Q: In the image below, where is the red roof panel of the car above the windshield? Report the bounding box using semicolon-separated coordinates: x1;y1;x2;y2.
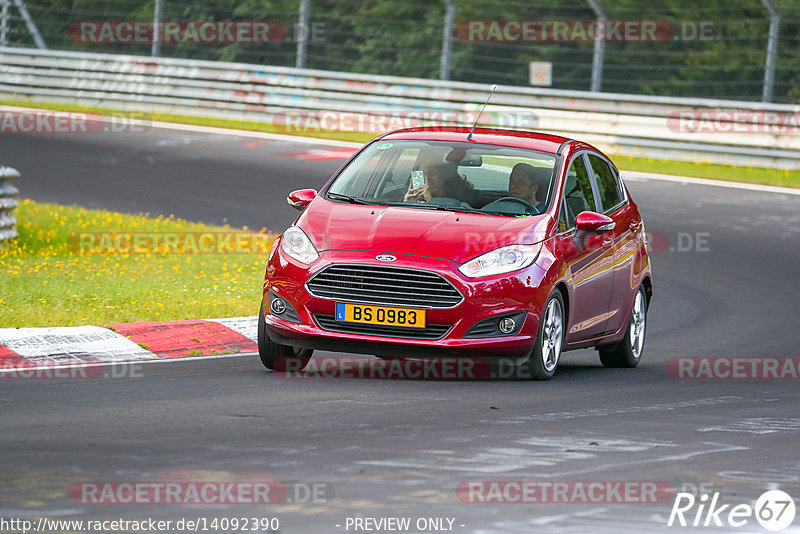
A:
381;126;573;154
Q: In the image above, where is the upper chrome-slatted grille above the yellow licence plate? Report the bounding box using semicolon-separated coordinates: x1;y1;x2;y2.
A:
306;265;464;308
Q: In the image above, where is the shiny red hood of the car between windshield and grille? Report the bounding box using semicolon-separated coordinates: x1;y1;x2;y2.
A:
296;197;551;263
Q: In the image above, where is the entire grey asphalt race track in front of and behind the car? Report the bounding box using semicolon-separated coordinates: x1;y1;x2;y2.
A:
0;126;800;533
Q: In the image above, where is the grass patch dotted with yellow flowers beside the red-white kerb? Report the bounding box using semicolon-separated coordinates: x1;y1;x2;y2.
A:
0;200;274;327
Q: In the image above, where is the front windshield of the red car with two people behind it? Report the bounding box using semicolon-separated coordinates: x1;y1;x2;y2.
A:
327;140;556;220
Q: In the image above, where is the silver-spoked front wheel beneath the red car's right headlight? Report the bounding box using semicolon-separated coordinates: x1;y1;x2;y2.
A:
521;290;566;380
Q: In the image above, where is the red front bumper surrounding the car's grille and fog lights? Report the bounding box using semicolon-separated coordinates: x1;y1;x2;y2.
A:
264;246;547;358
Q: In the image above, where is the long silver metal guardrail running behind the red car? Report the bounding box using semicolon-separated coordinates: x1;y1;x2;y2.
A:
0;48;800;169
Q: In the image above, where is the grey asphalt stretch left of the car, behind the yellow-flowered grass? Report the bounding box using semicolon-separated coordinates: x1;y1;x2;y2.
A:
0;128;343;231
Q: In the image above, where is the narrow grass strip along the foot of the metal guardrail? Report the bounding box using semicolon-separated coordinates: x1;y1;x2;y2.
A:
0;100;800;188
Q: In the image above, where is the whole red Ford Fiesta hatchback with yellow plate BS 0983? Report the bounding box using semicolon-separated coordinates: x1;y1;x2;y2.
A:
258;127;653;380
